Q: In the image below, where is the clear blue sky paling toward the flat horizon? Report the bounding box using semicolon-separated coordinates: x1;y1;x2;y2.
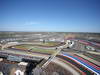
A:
0;0;100;32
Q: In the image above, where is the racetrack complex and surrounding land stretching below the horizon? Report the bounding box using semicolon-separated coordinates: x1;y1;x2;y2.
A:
0;32;100;75
